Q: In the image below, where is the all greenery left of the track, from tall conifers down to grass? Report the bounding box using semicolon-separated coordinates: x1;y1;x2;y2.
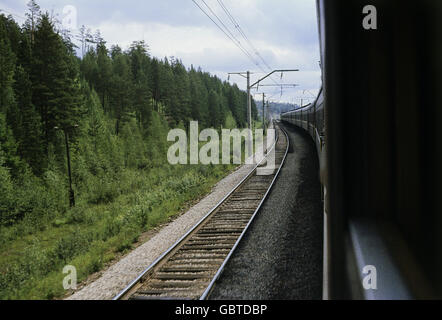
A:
0;1;257;299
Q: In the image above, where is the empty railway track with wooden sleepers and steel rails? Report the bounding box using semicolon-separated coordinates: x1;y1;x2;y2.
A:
114;127;289;300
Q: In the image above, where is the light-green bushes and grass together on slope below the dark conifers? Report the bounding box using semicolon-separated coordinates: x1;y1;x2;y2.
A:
0;109;266;299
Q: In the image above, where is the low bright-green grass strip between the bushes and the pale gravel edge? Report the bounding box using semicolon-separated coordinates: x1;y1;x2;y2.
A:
0;165;234;299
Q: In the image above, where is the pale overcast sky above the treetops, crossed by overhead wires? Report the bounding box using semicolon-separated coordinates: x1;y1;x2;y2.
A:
0;0;321;103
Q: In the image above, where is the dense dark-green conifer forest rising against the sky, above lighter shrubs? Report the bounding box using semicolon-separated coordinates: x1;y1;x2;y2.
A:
0;0;257;224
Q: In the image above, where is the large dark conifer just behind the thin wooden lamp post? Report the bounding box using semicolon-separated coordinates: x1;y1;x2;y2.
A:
31;14;80;155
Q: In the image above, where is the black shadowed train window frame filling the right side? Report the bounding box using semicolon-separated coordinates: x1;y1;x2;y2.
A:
318;0;442;298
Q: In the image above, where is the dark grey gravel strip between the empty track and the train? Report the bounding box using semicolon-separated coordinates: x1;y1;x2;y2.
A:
210;123;323;300
